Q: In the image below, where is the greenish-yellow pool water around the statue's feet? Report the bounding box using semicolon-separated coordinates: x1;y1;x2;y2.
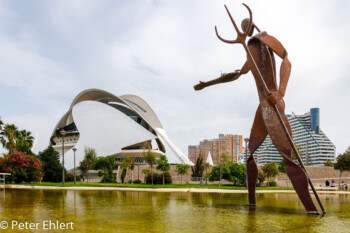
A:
0;189;350;232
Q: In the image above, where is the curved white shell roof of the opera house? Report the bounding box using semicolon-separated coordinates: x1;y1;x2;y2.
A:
52;89;193;165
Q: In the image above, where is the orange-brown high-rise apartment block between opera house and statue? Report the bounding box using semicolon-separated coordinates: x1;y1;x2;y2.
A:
188;134;243;165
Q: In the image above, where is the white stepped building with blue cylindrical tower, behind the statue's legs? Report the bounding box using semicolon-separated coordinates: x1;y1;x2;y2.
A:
254;108;336;166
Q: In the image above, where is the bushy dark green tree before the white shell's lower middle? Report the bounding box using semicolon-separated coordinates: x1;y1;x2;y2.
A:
92;156;115;183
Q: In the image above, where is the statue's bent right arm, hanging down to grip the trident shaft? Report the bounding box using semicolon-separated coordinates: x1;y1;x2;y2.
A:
255;32;292;97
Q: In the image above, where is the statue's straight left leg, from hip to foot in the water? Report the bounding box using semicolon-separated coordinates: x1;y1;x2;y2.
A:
247;106;267;205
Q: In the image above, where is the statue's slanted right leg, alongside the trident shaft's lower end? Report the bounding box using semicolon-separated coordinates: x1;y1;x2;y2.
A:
261;99;318;214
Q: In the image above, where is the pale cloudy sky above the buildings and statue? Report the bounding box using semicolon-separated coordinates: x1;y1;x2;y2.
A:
0;0;350;167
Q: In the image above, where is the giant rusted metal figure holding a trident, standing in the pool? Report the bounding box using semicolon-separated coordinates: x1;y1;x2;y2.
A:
194;4;326;214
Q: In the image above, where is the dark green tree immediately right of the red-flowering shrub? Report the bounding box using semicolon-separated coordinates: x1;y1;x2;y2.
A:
38;145;62;182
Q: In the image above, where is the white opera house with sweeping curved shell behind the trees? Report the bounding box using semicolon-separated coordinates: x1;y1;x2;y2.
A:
51;89;193;167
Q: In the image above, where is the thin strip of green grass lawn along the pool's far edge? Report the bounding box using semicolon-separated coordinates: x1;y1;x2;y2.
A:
17;181;293;190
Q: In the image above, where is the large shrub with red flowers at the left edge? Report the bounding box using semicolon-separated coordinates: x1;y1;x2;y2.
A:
0;151;43;184
